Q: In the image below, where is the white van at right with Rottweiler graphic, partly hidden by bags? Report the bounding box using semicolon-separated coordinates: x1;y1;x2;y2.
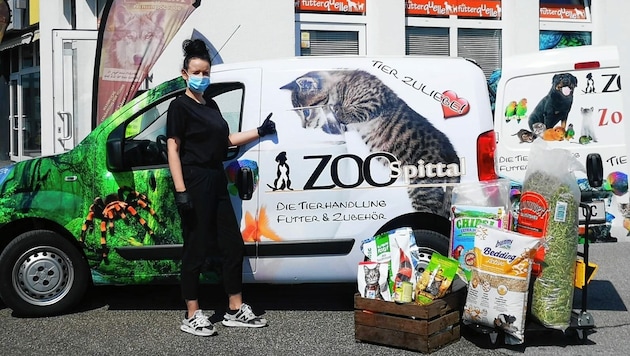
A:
494;46;630;241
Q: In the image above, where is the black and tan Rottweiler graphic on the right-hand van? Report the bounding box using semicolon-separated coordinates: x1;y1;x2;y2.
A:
529;73;577;130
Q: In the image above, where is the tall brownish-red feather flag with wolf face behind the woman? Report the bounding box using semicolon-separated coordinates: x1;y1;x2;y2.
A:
94;0;200;124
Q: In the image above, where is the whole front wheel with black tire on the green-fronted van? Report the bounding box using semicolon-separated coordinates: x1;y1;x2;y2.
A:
0;230;90;316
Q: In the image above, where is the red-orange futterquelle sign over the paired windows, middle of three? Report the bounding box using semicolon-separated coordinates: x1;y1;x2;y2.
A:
407;0;501;18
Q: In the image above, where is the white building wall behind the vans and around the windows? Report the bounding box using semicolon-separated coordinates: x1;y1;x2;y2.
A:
0;0;630;160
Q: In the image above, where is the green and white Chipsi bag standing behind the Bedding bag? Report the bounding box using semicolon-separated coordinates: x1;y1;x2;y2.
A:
448;179;509;282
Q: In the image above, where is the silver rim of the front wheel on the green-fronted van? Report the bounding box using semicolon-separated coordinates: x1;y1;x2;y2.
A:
13;246;74;306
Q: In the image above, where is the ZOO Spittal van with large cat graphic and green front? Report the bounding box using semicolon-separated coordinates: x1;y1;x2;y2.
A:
0;57;496;315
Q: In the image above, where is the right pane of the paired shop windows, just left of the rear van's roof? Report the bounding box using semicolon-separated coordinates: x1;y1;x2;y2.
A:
457;28;501;78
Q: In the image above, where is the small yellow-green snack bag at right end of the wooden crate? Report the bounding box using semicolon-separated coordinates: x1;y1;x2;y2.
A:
416;252;459;304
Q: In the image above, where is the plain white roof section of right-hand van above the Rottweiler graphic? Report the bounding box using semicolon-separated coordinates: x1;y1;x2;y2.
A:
501;45;619;77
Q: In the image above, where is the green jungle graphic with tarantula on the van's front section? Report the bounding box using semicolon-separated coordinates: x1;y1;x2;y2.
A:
0;78;227;283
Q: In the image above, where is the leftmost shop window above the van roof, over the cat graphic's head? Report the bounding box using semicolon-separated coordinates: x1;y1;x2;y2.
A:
300;30;359;56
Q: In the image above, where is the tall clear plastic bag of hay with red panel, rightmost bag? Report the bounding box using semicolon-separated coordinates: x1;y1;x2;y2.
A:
517;140;585;330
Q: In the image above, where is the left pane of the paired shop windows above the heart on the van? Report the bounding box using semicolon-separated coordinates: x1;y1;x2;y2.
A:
405;27;450;56
